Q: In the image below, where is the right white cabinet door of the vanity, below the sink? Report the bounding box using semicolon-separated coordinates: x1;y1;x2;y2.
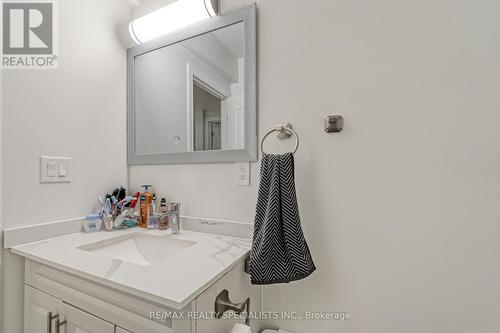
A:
60;303;115;333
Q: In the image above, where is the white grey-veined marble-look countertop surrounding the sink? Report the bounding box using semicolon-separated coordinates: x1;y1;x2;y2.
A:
12;228;251;310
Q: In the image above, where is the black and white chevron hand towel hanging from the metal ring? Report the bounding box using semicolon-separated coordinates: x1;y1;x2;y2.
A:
249;153;316;284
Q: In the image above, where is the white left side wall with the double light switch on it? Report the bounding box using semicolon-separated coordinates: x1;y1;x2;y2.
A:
1;0;130;333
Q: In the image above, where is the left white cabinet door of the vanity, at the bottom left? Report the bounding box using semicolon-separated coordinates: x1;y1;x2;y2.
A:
24;285;62;333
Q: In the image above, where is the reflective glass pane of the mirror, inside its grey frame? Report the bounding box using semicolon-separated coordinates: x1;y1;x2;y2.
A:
134;23;245;154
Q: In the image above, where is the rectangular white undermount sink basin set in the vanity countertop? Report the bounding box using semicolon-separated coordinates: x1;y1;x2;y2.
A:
79;232;196;266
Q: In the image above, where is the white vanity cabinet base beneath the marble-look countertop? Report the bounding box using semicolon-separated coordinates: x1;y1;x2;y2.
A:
24;259;261;333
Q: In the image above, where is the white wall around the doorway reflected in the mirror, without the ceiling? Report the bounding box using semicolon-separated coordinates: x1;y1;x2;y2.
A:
134;44;230;154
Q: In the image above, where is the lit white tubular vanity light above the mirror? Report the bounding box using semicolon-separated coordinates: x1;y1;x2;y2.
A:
129;0;219;44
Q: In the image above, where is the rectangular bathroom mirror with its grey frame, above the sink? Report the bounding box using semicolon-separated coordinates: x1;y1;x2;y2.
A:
127;5;257;165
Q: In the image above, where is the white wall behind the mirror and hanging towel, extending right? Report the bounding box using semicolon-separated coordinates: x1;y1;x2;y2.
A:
129;0;500;333
